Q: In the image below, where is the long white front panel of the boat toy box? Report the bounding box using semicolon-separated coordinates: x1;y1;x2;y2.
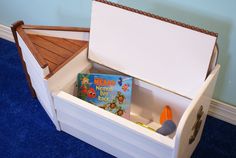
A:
54;92;173;158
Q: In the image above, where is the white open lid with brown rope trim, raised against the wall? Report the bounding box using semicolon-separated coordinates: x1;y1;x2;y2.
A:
88;0;217;98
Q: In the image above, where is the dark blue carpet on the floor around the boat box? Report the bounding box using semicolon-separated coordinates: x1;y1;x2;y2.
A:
0;38;236;158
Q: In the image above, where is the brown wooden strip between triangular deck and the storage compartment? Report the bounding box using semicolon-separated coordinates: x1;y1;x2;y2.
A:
45;43;88;80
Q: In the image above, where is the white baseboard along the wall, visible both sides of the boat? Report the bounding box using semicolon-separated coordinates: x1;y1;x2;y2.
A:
0;24;236;125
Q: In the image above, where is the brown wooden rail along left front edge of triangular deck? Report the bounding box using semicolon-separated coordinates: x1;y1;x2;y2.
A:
16;26;48;68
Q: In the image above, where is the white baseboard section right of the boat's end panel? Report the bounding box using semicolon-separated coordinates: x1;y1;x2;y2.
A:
208;99;236;125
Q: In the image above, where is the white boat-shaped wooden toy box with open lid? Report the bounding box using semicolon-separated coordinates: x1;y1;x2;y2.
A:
12;0;220;158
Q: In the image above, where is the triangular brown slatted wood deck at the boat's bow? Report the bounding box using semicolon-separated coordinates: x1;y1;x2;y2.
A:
28;34;88;74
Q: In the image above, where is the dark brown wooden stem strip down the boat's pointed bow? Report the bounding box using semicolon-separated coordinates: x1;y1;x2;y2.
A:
11;21;36;98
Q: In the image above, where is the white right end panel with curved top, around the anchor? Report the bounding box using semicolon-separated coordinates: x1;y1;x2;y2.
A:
174;65;220;158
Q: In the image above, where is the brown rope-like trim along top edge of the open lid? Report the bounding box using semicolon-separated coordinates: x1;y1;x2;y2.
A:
95;0;218;37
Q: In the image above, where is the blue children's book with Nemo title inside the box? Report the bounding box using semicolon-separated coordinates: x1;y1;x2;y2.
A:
77;73;132;119
